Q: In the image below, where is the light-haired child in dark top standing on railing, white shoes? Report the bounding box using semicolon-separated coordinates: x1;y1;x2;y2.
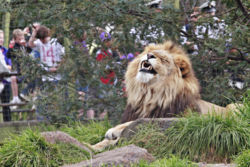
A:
7;29;31;104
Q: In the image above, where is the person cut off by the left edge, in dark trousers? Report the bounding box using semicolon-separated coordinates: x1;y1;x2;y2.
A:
0;30;11;121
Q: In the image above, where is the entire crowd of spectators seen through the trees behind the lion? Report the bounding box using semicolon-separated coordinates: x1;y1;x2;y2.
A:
0;0;244;121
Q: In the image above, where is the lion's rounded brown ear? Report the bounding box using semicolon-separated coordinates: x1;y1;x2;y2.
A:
174;57;191;78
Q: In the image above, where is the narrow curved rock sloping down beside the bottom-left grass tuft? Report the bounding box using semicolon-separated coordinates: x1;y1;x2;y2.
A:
41;131;93;156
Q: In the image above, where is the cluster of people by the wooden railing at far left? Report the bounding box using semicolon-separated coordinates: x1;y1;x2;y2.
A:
0;23;64;121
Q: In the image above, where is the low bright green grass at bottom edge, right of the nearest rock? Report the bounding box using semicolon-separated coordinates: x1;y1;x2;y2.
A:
132;156;198;167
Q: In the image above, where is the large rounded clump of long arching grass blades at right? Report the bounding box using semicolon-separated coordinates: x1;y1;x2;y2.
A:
166;115;250;162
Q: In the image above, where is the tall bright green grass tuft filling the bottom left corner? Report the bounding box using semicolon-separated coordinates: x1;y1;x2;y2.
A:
0;130;63;167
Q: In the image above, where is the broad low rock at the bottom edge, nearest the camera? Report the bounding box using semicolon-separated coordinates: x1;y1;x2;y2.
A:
63;145;154;167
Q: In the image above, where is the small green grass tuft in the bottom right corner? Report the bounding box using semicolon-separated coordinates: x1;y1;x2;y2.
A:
235;149;250;167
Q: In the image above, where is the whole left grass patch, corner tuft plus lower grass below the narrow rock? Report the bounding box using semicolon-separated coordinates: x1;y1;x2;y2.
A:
0;129;90;167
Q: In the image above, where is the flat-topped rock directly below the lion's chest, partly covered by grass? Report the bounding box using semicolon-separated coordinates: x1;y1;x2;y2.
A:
121;118;178;139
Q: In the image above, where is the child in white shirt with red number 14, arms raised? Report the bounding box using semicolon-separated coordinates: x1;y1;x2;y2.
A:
29;26;65;81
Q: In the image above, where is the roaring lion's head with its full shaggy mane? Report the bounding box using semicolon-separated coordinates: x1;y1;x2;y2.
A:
122;41;200;122
